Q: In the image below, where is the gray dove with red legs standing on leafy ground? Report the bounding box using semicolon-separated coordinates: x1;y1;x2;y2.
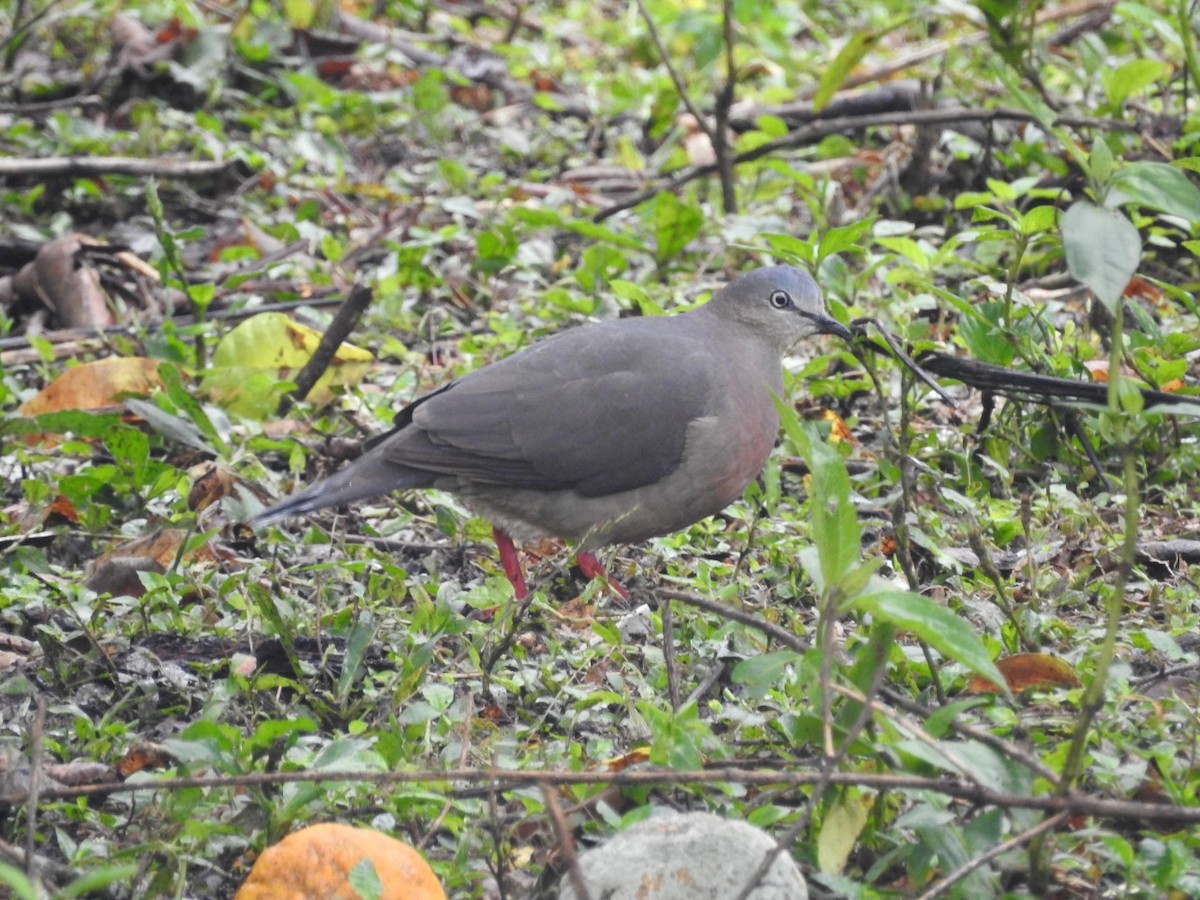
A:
256;271;850;599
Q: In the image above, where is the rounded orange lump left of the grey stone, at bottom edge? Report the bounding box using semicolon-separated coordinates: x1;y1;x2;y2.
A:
234;822;445;900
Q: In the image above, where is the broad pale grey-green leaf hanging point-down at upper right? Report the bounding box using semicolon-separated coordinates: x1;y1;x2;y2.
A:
1062;200;1141;312
